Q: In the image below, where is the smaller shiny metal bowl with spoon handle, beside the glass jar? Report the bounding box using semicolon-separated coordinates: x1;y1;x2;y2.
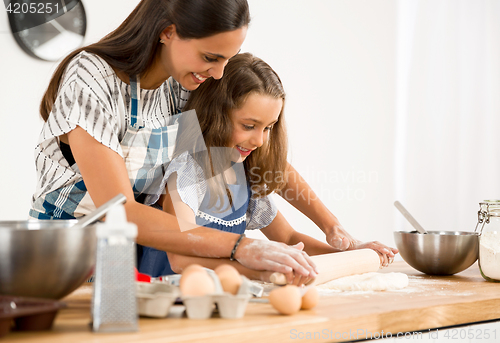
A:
394;231;479;275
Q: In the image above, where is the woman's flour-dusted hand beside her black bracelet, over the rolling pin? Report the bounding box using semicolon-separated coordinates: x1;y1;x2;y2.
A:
234;238;318;283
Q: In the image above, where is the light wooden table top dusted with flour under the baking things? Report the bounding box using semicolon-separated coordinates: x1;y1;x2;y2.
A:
2;262;500;343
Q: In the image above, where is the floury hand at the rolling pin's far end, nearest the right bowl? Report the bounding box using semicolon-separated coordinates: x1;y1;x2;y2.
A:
326;224;399;267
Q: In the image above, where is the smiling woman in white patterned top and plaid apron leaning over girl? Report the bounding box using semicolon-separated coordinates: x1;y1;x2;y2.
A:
30;0;391;284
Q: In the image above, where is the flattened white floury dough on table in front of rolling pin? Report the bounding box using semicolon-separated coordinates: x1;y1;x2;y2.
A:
317;272;408;291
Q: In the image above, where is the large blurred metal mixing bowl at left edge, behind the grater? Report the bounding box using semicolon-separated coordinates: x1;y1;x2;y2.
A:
0;220;97;299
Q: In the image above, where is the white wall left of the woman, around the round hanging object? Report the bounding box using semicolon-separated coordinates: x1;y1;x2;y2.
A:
0;0;138;220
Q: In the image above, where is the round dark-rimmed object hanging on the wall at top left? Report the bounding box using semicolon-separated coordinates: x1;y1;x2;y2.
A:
4;0;87;61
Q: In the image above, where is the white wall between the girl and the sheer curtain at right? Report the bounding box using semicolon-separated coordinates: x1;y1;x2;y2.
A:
243;0;396;245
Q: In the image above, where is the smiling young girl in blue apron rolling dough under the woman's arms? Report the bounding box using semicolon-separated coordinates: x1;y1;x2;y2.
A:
140;53;398;283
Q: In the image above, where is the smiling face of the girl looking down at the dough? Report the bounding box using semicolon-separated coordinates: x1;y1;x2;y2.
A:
229;93;283;162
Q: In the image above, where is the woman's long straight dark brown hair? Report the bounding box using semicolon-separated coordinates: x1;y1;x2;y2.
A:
40;0;250;121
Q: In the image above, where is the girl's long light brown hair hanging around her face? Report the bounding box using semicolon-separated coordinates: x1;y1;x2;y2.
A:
182;53;288;205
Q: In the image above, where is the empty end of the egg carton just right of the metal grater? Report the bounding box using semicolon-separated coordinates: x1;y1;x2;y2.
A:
135;282;181;318
